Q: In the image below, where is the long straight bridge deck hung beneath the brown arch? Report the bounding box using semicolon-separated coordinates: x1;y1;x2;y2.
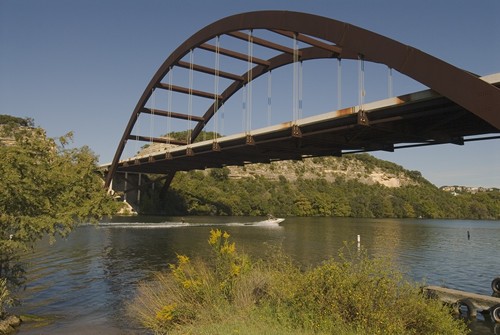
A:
102;73;500;174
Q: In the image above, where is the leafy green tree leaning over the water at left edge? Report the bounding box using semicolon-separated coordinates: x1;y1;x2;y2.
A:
0;124;118;296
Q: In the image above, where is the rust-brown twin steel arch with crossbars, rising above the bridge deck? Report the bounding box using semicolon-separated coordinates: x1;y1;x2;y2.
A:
106;11;500;186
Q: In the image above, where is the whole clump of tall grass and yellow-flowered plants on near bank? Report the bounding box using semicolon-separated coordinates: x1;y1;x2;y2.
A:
128;230;468;335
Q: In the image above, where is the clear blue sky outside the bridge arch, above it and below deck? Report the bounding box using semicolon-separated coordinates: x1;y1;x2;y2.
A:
0;0;500;187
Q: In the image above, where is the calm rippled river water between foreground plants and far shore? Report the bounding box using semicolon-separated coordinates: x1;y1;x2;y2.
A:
13;217;500;335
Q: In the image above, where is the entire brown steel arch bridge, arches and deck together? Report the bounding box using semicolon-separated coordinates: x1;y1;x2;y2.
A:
105;11;500;192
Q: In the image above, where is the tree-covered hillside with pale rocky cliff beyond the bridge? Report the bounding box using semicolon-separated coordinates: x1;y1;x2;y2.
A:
141;154;500;219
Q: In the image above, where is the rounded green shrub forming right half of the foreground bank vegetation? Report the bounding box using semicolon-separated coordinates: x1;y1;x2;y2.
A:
270;247;466;334
